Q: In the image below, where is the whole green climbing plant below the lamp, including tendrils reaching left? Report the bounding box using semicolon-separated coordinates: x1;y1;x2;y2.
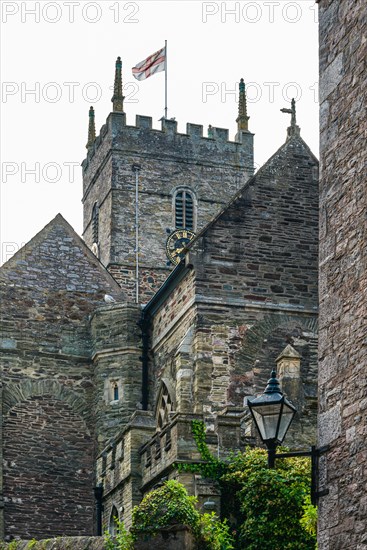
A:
181;421;317;550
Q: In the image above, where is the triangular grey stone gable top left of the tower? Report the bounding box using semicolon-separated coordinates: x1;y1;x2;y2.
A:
0;214;123;300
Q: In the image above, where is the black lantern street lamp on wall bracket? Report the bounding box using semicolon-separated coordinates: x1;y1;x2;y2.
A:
247;370;329;505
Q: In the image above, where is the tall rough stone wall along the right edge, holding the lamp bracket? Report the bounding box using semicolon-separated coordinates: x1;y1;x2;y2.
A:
319;0;367;550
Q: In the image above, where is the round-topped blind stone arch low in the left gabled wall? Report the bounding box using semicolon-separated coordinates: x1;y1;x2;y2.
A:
4;396;94;539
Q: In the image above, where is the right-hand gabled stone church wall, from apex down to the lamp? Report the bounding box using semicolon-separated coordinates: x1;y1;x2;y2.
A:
188;137;318;446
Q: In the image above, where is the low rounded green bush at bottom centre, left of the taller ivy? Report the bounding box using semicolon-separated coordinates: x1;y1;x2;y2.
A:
133;480;234;550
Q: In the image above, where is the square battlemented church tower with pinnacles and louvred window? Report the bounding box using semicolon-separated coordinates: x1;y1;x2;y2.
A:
82;57;254;303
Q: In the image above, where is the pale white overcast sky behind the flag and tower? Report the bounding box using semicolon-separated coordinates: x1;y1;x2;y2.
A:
0;0;318;268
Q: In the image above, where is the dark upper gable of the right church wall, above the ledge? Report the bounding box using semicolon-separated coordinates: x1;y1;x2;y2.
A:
191;137;318;310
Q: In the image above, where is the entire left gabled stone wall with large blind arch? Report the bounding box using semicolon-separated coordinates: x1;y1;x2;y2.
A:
0;216;121;536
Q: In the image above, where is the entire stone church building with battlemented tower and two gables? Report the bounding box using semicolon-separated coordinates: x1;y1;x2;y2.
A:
0;59;318;540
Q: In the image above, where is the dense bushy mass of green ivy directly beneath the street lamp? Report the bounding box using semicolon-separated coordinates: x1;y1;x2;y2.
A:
222;448;316;550
